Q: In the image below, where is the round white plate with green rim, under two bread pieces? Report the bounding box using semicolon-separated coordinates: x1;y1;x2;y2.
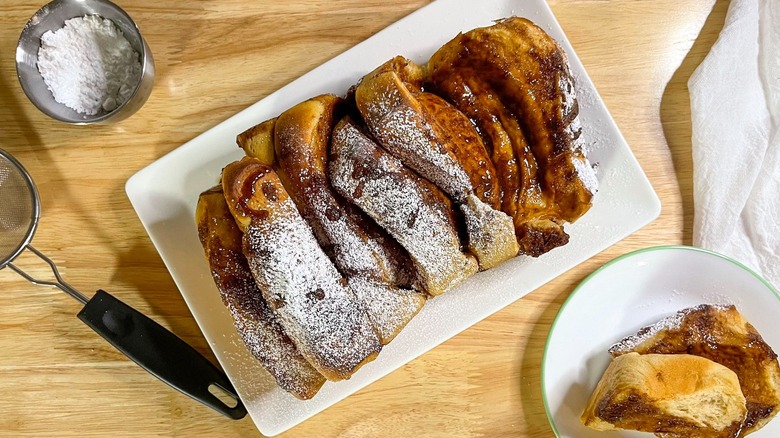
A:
542;246;780;438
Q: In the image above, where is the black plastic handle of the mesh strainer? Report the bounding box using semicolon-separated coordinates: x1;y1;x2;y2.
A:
78;290;246;420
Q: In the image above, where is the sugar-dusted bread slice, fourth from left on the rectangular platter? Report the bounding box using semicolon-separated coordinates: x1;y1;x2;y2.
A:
329;119;477;294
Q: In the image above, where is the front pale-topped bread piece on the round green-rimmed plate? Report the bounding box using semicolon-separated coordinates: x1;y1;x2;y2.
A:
581;353;747;437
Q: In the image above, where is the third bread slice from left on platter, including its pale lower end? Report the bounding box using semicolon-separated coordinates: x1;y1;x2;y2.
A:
274;94;425;345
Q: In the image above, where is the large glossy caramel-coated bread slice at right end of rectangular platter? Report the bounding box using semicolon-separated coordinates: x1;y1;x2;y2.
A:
428;17;597;256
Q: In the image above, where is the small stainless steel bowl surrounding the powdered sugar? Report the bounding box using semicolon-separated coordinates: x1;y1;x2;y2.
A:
16;0;154;125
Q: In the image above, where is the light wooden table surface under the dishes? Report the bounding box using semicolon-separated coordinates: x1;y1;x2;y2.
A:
0;0;728;437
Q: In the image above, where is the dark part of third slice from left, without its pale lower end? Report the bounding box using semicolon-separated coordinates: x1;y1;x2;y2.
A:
274;94;414;286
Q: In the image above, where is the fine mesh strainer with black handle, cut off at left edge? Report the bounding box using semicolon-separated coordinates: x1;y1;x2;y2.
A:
0;149;246;419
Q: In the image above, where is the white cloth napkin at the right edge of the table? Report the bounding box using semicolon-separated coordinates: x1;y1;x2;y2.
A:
688;0;780;287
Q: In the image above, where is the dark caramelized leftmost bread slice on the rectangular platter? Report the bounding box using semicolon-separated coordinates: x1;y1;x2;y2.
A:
196;187;325;400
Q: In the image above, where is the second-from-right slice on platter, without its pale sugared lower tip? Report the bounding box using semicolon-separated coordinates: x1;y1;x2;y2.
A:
355;56;499;208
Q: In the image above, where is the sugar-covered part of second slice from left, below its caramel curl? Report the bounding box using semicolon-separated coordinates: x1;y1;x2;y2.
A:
244;175;381;380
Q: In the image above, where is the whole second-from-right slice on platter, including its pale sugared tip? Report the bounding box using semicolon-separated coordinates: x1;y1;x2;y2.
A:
355;57;518;269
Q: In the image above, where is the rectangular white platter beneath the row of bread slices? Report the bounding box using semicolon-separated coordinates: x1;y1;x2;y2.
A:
126;0;660;435
